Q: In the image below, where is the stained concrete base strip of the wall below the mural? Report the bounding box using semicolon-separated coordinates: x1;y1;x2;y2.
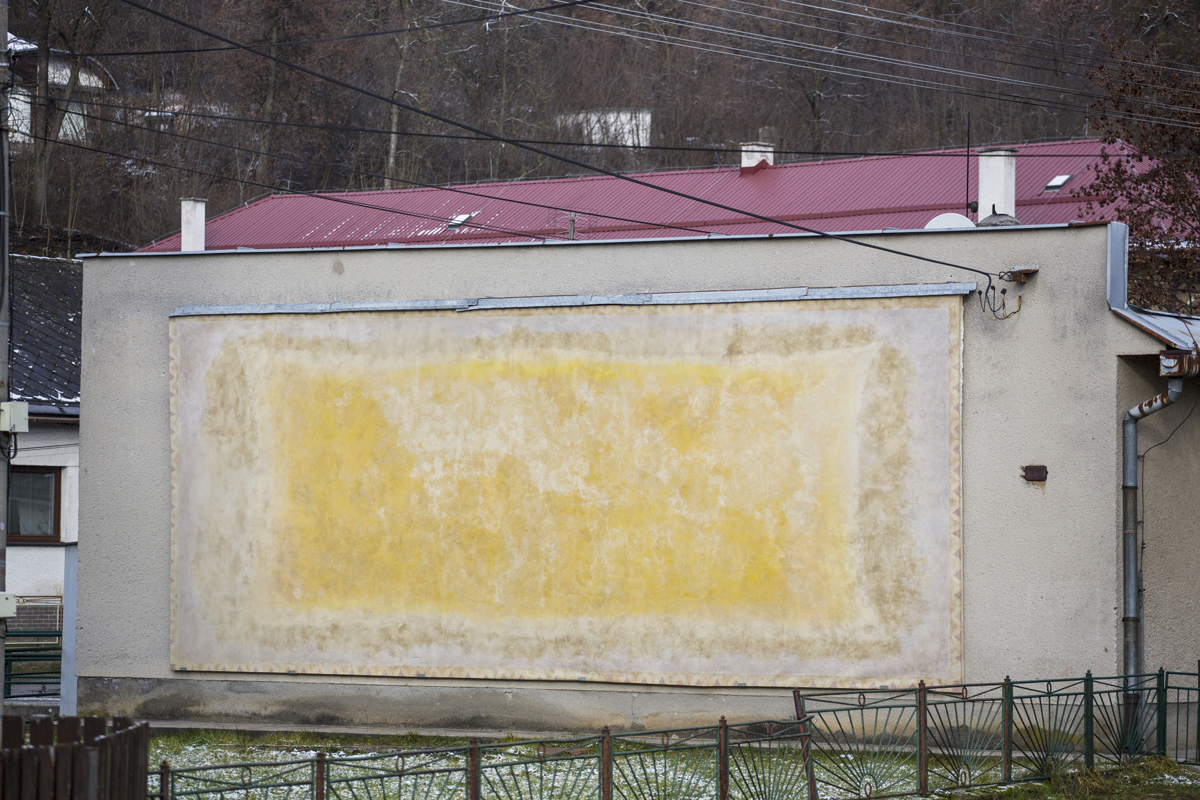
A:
79;678;796;732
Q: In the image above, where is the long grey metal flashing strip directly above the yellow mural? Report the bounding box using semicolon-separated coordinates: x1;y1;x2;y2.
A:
170;283;976;317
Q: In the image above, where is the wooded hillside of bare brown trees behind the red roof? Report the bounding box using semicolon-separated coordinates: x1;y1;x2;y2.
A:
11;0;1200;254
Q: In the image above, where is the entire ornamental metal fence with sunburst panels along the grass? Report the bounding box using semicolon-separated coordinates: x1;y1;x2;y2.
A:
149;668;1200;800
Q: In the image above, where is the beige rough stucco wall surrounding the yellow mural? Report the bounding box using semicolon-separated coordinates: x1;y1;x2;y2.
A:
77;221;1195;728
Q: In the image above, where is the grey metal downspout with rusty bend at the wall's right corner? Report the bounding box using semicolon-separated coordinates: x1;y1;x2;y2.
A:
1121;378;1183;688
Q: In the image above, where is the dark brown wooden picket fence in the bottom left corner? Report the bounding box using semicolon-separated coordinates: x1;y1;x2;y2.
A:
0;715;150;800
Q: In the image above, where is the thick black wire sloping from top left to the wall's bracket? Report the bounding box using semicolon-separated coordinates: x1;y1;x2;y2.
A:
121;0;1022;316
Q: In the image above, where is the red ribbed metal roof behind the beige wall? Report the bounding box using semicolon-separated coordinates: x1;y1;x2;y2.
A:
142;139;1100;252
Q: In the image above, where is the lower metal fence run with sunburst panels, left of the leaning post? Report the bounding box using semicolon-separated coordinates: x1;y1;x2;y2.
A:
149;718;809;800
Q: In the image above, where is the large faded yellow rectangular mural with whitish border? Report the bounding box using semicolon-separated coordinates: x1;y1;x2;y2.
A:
170;296;961;686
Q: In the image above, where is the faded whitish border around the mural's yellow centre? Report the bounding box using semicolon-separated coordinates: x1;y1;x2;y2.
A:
170;296;962;687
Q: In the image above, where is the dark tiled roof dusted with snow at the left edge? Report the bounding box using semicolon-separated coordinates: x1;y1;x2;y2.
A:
10;255;83;416
